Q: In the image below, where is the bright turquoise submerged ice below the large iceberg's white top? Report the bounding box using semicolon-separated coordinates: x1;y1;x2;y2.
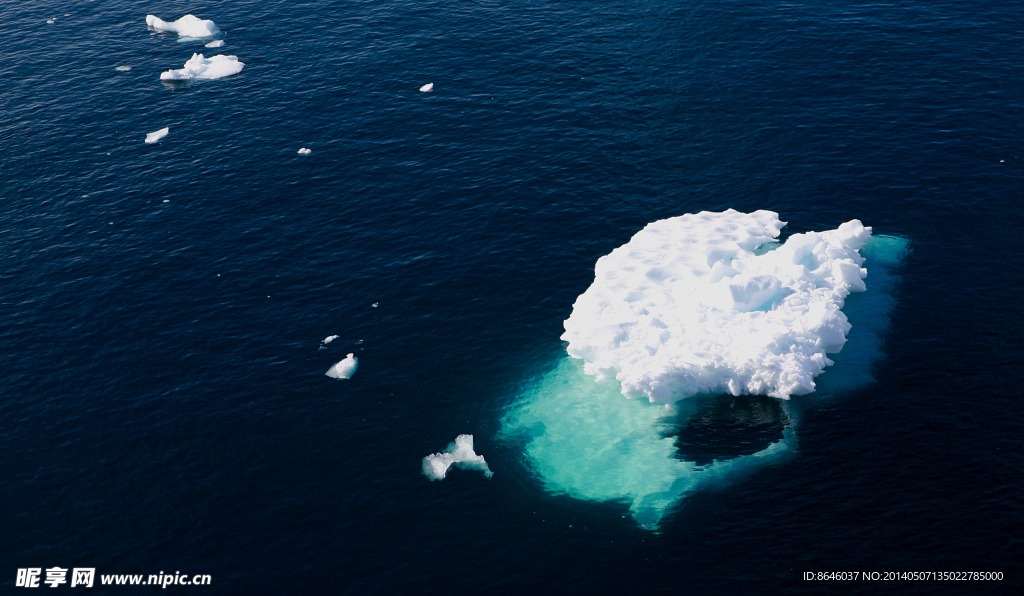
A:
502;358;797;528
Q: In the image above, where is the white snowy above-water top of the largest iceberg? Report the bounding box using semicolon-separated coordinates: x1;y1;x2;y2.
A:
562;209;871;403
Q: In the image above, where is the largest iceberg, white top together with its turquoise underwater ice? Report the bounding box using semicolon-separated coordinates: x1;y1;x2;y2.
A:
501;210;906;528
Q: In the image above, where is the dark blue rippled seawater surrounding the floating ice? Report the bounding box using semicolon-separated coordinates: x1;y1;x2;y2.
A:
0;0;1024;594
